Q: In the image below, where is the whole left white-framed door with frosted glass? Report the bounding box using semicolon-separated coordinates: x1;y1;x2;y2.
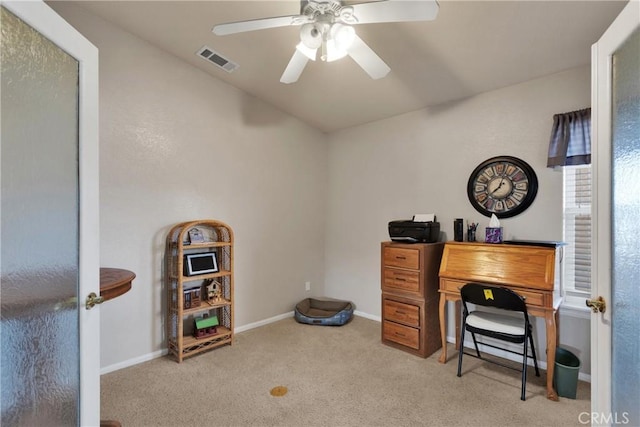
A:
0;0;100;426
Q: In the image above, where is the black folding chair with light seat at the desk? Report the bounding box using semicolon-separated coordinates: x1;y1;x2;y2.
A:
458;283;540;400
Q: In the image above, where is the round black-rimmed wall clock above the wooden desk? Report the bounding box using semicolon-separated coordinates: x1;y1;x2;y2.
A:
467;156;538;218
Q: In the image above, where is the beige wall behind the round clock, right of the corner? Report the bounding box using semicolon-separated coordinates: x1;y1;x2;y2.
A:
325;66;591;372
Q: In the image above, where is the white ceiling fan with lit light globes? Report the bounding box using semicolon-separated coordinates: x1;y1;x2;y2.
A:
213;0;439;83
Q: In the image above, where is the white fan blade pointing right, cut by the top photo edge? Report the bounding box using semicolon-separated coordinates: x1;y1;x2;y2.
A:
352;0;439;24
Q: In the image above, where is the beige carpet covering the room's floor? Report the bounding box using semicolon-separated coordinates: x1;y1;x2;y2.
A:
101;317;590;427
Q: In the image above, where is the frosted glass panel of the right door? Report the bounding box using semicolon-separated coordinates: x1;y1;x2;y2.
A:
611;28;640;426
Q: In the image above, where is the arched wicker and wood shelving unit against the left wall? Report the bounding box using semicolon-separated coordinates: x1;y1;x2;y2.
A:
165;220;233;362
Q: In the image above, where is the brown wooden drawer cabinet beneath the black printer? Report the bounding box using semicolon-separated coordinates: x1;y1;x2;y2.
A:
381;242;444;357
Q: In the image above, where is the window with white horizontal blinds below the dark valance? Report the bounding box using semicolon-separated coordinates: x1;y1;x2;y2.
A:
563;165;591;294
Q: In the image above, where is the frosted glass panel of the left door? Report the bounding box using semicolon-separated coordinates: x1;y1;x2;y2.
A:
0;7;80;426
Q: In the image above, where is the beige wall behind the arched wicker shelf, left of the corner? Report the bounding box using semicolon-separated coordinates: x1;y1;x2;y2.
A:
53;4;328;367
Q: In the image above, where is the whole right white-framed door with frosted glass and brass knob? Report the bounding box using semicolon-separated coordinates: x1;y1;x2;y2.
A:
592;0;640;426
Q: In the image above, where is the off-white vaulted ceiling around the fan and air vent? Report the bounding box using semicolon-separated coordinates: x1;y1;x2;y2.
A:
58;0;626;132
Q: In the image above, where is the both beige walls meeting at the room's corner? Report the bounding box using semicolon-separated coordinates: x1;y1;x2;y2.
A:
53;3;590;369
